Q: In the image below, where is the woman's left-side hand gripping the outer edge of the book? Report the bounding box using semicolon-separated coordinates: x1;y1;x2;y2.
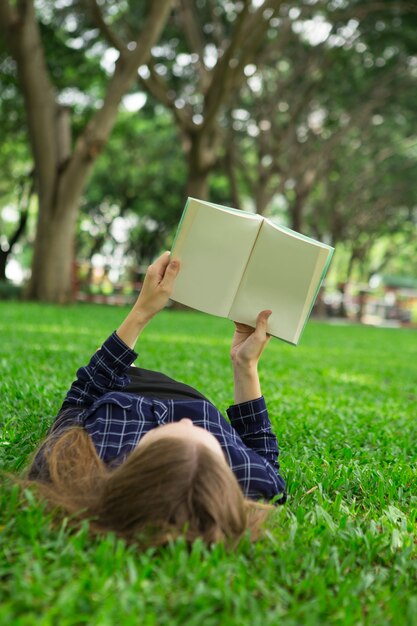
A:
133;252;180;321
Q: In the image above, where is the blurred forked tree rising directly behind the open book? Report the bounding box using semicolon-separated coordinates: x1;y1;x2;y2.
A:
136;0;283;198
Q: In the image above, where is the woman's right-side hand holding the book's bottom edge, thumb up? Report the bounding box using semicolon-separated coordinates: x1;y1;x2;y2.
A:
230;310;272;367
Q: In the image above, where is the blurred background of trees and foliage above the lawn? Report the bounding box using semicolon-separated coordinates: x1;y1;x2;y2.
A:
0;0;417;326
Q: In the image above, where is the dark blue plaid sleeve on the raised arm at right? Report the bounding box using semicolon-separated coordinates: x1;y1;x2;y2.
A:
227;396;279;471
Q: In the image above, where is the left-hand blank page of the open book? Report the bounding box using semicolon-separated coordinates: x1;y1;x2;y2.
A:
171;198;262;317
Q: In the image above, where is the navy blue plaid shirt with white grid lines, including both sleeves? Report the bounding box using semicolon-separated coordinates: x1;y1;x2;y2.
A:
40;332;286;504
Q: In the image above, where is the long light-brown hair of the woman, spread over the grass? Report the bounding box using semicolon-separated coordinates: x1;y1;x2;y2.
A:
18;427;274;545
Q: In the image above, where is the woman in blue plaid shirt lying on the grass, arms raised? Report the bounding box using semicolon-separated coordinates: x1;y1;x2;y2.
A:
24;253;286;545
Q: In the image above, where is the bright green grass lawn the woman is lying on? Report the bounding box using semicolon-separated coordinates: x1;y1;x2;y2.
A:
0;303;417;626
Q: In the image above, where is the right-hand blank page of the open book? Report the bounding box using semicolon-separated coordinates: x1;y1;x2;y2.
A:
229;220;330;344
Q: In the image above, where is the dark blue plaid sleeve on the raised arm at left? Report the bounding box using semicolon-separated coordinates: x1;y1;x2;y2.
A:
61;331;137;410
